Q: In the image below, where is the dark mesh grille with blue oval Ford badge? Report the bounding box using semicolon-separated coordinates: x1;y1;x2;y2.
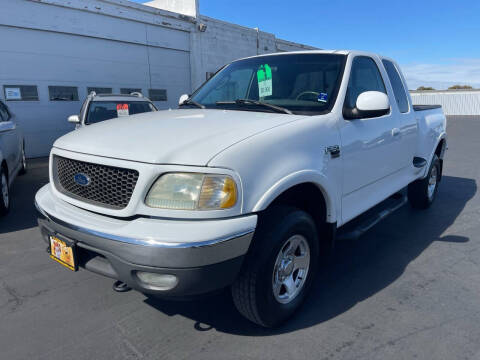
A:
53;155;138;210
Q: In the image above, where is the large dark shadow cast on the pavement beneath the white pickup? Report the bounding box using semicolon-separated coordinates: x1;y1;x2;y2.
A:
145;176;477;336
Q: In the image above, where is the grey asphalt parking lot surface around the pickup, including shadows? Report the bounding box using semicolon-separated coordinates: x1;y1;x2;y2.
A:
0;117;480;360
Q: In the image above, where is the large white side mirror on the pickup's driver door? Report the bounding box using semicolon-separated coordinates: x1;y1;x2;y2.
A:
343;91;390;120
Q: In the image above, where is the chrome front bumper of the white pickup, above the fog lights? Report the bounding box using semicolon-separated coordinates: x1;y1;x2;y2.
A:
35;185;257;267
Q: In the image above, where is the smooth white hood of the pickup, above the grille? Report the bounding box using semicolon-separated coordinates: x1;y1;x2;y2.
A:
54;109;303;166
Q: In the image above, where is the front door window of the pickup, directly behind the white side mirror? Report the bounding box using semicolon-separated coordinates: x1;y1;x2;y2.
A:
345;56;387;109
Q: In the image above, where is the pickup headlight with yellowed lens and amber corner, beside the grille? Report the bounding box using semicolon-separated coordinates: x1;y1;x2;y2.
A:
145;173;237;210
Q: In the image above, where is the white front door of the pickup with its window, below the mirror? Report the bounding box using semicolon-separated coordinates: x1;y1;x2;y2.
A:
340;56;401;223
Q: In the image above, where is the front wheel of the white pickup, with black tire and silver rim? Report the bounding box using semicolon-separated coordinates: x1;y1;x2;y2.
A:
231;207;319;327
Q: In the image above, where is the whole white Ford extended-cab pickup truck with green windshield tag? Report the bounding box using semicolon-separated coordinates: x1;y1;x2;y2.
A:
35;51;446;327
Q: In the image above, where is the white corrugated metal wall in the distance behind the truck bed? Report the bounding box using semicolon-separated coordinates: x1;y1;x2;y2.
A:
410;90;480;115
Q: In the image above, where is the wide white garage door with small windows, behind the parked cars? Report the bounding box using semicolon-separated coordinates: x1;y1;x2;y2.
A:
0;23;191;157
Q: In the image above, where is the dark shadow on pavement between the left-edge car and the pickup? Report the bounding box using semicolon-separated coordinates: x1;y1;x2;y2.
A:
0;159;48;234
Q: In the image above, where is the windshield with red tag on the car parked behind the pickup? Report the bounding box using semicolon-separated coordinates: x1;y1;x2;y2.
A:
85;101;156;125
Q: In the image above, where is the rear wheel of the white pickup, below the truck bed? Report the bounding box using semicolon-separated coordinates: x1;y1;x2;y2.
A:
408;155;442;209
